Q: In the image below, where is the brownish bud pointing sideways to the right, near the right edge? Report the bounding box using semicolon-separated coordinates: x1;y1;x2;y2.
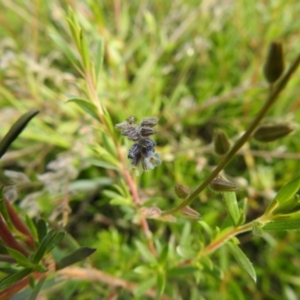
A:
253;124;295;142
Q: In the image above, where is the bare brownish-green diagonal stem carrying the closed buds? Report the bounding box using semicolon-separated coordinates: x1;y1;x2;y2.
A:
161;54;300;216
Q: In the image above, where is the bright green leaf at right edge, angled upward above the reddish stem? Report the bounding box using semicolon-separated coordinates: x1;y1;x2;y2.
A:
266;176;300;214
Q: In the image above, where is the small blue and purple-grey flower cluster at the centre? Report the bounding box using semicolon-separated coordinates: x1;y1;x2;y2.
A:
115;116;161;175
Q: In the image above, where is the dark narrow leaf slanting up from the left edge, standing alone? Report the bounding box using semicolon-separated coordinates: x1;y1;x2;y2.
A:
0;109;39;158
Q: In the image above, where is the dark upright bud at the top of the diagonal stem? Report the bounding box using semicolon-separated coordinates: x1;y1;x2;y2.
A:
263;42;284;84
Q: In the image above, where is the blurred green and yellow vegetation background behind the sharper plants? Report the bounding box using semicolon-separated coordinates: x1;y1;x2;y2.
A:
0;0;300;300
